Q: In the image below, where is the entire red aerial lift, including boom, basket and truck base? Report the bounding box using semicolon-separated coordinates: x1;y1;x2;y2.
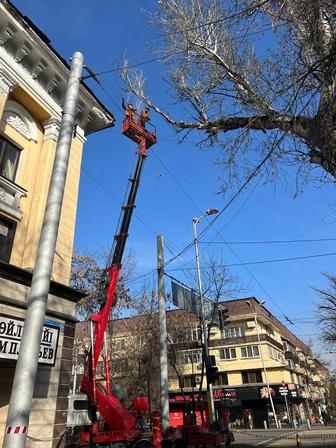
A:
67;117;234;448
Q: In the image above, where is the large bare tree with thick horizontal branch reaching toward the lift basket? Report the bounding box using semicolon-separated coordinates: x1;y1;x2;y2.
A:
123;0;336;188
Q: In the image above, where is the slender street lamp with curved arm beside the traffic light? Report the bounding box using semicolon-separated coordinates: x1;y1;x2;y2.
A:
193;208;219;424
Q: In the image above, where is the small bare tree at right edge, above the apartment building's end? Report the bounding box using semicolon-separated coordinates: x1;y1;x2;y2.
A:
314;274;336;347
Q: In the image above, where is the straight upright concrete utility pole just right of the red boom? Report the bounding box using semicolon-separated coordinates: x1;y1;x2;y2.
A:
157;235;170;430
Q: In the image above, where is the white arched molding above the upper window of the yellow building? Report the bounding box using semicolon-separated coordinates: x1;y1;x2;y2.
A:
2;100;37;142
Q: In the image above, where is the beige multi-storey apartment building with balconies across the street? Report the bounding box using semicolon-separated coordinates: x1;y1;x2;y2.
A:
76;297;329;428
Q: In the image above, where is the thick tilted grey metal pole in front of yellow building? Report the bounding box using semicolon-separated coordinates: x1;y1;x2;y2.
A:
3;52;84;448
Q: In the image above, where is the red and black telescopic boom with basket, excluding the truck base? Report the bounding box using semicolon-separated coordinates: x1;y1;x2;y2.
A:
77;117;156;446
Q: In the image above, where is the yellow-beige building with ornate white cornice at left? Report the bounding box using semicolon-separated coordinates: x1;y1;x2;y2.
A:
0;1;114;448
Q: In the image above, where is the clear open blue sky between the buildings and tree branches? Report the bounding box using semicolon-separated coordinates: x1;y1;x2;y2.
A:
14;0;336;366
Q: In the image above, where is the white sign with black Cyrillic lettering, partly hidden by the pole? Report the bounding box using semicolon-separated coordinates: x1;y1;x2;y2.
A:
0;315;59;366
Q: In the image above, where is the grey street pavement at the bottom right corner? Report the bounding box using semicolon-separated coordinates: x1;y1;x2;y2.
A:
232;426;336;448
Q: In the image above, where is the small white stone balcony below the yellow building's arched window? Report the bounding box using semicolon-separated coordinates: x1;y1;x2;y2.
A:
0;176;27;221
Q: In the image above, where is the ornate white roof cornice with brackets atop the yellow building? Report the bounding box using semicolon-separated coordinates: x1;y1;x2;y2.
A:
0;1;114;134
